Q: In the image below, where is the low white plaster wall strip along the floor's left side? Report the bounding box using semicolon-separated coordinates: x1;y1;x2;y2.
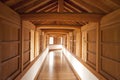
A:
21;48;49;80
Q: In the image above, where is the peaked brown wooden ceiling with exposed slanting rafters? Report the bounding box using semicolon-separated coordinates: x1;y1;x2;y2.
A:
1;0;120;26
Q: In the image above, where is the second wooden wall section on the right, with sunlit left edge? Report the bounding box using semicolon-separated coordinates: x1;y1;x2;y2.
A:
81;23;98;69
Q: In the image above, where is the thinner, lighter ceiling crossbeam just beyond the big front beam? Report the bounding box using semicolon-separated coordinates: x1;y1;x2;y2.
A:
36;25;81;30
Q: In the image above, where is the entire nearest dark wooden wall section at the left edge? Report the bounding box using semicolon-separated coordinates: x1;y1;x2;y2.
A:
0;2;21;80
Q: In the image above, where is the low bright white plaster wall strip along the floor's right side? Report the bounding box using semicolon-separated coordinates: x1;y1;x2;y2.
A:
63;47;99;80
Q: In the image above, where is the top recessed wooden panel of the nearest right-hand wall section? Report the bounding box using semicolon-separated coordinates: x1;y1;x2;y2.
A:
101;23;120;42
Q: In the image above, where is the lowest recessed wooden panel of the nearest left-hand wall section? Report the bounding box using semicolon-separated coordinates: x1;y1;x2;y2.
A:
2;57;19;80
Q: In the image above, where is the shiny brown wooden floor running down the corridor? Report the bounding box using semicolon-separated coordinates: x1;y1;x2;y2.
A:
37;50;78;80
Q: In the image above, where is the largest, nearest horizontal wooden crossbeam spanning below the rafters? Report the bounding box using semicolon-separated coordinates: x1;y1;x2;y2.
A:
21;13;103;22
